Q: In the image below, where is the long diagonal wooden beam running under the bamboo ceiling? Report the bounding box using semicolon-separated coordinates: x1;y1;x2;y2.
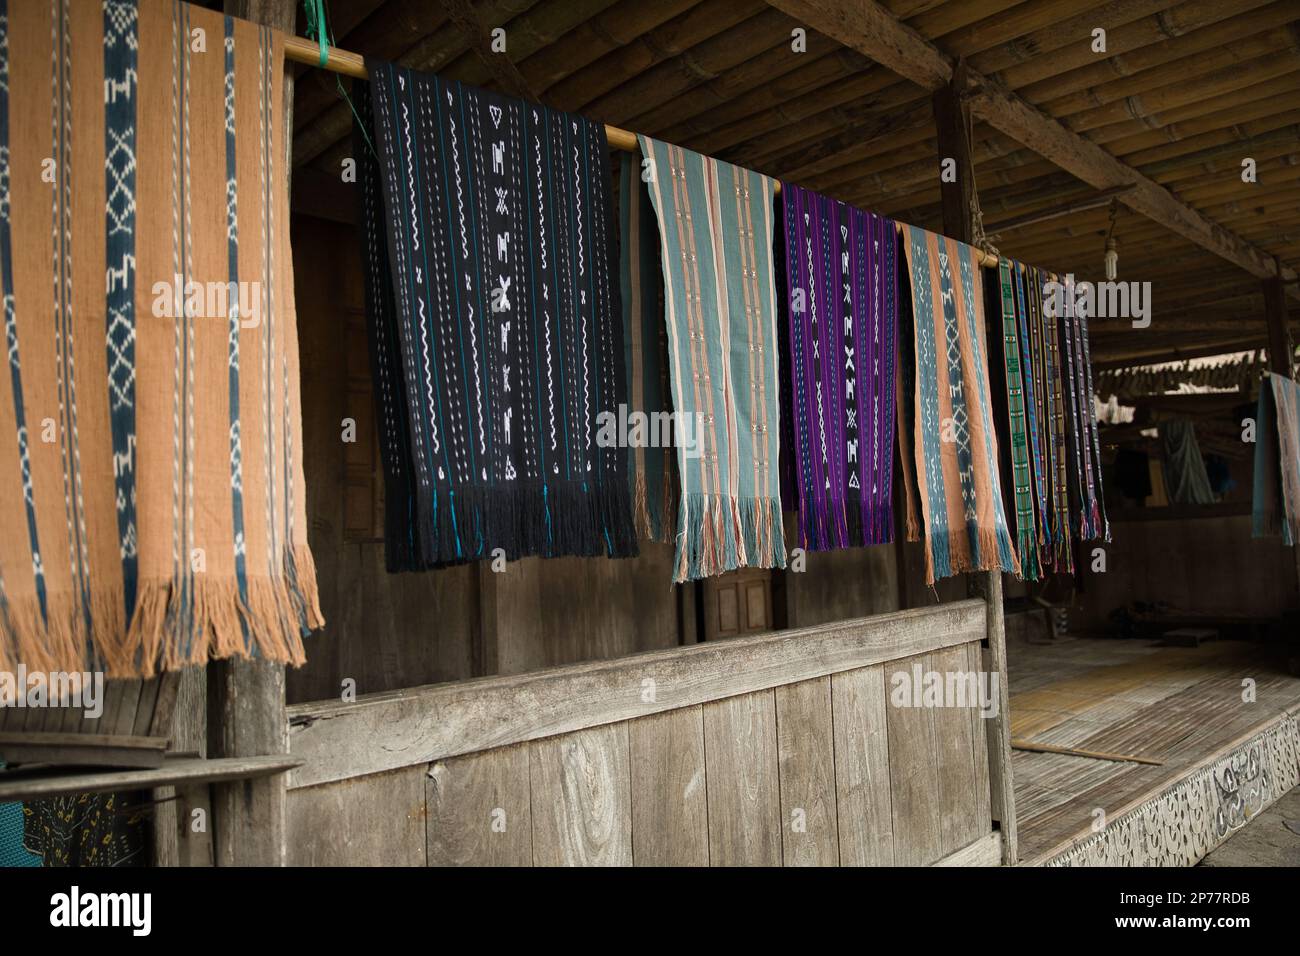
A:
767;0;1300;298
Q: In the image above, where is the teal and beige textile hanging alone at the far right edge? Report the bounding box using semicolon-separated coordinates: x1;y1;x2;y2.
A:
1251;372;1300;545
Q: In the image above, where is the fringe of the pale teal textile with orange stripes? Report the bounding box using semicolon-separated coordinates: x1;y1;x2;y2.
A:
673;493;785;584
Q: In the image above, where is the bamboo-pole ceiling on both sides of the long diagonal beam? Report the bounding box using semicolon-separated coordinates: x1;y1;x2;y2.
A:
284;0;1300;352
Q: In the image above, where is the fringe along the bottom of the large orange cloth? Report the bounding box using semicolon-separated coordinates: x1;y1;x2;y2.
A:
0;544;325;678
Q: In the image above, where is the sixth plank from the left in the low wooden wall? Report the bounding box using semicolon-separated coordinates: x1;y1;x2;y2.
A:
774;678;840;866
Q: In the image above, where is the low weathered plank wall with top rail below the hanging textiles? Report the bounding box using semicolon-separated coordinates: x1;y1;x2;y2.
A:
289;601;1000;866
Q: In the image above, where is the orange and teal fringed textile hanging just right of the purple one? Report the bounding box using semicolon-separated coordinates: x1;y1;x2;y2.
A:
900;226;1021;584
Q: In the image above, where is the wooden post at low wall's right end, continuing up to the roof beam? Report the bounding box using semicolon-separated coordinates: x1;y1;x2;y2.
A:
933;60;1017;865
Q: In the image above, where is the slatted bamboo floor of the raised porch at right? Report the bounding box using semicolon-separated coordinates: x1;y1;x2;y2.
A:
1008;639;1300;861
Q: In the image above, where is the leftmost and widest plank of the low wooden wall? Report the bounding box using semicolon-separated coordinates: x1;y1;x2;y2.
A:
285;767;426;866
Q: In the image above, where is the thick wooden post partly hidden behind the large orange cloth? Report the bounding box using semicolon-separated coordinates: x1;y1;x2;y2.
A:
207;0;298;866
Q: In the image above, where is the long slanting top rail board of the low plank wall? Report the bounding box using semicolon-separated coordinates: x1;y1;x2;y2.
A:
289;601;985;787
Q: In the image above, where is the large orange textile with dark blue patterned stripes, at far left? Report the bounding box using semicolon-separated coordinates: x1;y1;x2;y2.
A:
0;0;322;676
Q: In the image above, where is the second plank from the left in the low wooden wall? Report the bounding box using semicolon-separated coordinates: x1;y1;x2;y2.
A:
426;744;533;866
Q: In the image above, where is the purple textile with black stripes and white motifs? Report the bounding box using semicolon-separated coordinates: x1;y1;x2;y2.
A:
781;182;898;550
